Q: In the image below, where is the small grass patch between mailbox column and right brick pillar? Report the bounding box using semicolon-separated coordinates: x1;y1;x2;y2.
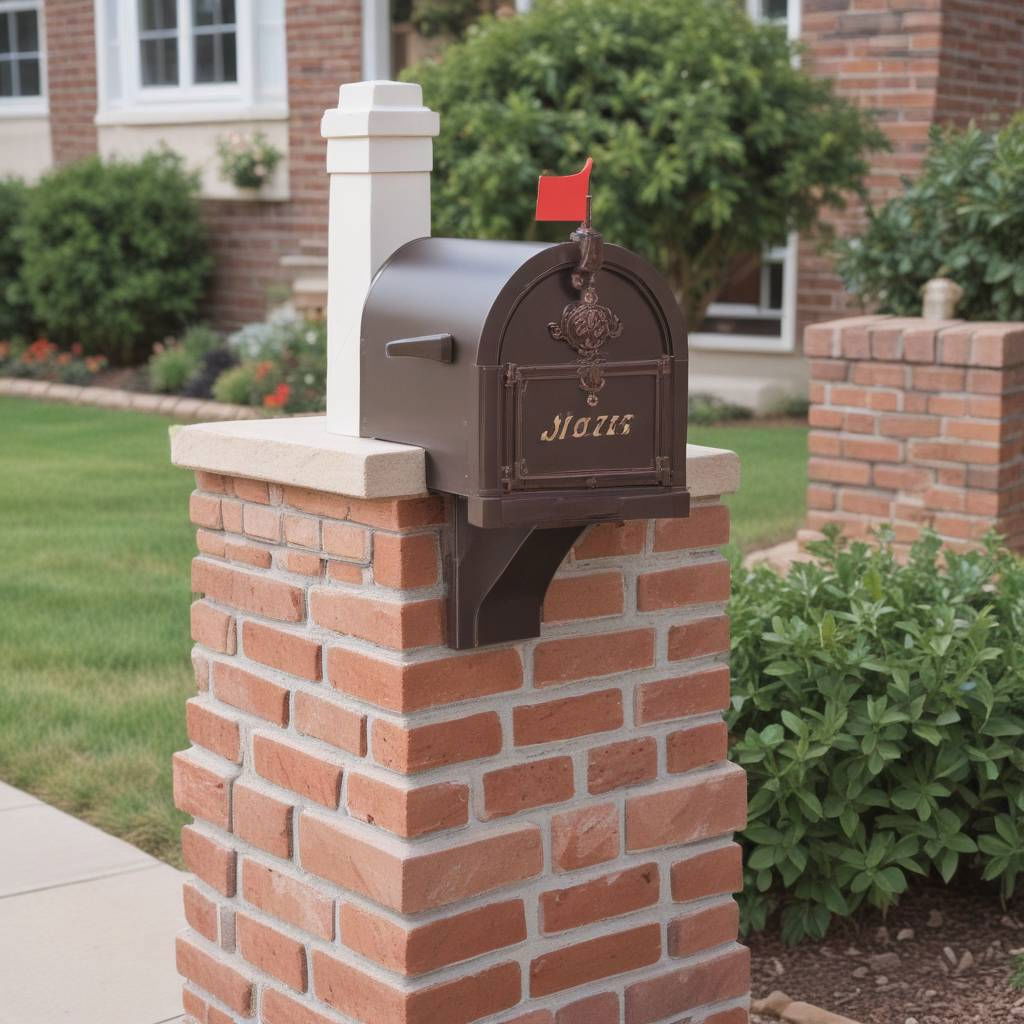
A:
688;422;807;552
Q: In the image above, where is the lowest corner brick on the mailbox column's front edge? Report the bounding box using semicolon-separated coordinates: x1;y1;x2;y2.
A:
313;950;522;1024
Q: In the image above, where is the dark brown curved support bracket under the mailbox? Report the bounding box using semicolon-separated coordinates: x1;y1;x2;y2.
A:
444;495;585;650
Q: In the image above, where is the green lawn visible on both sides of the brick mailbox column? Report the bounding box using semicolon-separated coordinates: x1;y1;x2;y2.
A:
0;398;807;861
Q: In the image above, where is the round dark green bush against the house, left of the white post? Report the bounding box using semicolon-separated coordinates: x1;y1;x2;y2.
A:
22;152;211;362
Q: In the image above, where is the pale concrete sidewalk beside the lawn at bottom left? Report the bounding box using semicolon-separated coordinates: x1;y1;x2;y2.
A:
0;782;184;1024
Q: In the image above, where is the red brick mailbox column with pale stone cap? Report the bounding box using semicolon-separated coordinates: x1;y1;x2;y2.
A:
167;419;750;1024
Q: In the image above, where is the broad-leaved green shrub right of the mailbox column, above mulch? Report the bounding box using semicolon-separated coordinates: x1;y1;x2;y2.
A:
729;531;1024;941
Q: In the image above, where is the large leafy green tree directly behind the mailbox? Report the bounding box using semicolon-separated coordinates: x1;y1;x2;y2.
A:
406;0;884;324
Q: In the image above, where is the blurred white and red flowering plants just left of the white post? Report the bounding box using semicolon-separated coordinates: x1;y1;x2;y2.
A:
213;312;327;413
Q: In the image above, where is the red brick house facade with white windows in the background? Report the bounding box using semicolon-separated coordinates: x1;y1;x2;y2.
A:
0;0;1024;399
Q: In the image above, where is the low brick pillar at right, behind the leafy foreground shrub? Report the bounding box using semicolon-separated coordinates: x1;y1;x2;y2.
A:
804;316;1024;550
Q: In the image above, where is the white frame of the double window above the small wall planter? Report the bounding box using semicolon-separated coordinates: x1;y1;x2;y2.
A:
95;0;288;125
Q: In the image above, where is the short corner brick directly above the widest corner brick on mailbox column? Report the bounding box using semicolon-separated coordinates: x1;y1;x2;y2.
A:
346;772;469;839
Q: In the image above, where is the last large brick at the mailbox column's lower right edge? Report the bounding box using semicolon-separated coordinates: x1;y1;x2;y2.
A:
625;946;751;1024
